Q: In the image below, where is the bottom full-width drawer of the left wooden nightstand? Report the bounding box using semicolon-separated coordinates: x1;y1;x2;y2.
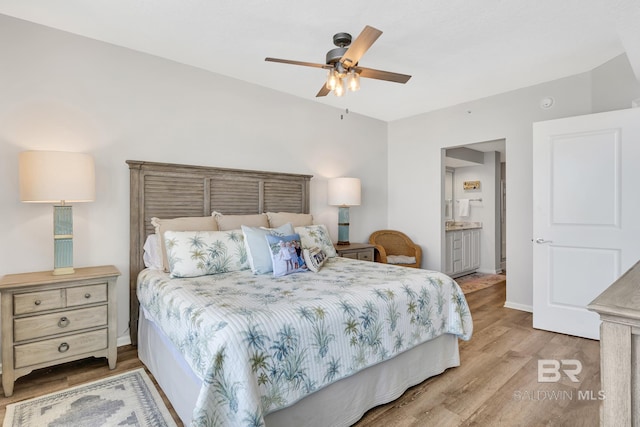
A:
14;328;108;369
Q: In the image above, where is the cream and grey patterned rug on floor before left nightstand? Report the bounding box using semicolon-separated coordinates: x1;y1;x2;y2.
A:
2;368;176;427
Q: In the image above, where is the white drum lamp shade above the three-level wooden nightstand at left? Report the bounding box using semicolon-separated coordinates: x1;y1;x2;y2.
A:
19;151;96;203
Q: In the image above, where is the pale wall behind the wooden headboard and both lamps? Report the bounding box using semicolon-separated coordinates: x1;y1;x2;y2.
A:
0;15;387;352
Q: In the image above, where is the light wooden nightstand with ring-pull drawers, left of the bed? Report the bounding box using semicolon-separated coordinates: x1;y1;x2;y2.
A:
0;265;120;397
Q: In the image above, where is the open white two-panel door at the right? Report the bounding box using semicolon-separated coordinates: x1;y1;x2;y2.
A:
532;108;640;339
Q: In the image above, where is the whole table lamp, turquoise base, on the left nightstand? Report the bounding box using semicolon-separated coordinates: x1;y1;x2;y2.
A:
19;151;95;275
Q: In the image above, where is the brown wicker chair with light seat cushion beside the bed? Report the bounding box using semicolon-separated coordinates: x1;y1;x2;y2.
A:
369;230;422;268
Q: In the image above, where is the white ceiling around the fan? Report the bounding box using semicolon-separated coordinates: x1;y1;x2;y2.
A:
0;0;640;121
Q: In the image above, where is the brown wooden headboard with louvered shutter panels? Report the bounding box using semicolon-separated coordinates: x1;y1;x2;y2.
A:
127;160;311;344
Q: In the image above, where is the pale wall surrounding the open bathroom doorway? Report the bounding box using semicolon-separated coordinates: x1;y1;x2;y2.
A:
389;58;640;311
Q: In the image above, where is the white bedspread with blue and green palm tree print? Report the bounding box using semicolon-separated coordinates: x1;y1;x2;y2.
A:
138;258;473;426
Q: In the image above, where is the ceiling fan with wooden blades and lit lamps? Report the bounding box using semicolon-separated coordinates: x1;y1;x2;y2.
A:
264;25;411;97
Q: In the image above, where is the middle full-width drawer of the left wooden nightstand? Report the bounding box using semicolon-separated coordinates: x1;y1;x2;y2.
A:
13;305;107;342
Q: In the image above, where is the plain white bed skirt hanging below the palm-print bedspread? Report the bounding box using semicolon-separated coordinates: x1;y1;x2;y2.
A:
138;310;460;427
